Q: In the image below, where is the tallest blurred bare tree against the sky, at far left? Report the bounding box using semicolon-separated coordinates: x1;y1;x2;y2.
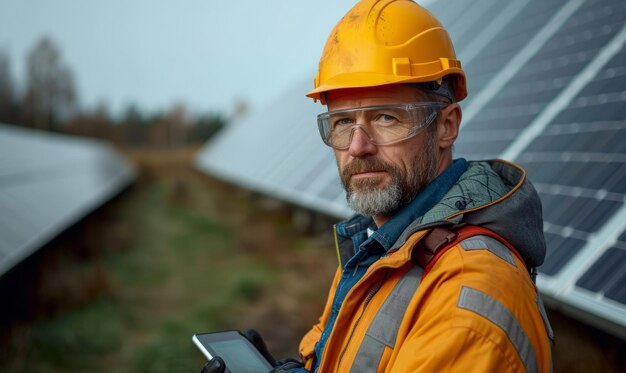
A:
24;37;76;130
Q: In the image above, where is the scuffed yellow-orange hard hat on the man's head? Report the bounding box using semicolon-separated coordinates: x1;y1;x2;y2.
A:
307;0;467;104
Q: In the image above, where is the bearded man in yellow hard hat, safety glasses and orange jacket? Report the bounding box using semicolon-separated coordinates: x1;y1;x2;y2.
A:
202;0;551;372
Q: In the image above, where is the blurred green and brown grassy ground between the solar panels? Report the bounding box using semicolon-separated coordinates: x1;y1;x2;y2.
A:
0;151;336;372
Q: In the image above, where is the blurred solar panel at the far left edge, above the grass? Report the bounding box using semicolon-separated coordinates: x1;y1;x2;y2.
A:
0;125;134;275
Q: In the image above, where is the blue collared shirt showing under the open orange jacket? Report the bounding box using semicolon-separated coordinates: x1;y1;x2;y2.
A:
313;158;467;371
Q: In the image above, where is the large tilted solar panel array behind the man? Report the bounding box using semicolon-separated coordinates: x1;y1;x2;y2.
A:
199;0;626;338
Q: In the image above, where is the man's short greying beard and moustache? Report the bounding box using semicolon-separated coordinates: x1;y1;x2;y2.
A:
340;133;438;216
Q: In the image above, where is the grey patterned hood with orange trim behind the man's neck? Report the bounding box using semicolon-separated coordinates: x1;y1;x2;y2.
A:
392;160;546;268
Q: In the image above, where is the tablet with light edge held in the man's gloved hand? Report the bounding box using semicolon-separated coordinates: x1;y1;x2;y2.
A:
191;330;273;373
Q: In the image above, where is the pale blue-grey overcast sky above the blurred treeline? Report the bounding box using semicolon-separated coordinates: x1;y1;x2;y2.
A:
0;0;355;113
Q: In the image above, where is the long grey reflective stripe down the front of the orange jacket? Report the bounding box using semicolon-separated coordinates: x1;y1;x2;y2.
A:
350;266;423;373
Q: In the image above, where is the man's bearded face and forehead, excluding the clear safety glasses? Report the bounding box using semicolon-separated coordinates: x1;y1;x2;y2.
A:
327;85;439;217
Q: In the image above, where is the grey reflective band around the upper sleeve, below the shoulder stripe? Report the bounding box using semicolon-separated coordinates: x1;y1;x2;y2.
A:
457;286;537;373
